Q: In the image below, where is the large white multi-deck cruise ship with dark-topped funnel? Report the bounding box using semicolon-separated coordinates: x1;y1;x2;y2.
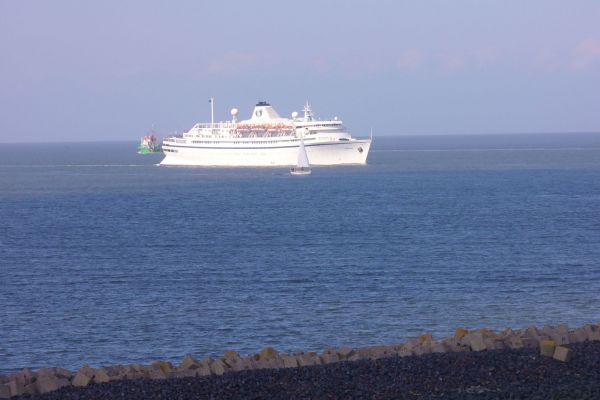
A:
160;99;371;167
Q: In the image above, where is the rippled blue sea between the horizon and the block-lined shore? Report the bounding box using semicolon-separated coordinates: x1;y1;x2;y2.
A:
0;134;600;373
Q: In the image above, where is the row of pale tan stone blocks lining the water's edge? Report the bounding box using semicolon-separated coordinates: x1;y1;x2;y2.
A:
0;324;600;399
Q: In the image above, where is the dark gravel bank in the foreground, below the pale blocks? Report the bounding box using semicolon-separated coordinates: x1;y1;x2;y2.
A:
16;342;600;400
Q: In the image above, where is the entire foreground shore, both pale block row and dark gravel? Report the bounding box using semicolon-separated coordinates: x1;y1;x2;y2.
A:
0;324;600;400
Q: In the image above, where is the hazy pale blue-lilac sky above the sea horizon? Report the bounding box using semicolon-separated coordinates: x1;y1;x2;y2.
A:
0;0;600;142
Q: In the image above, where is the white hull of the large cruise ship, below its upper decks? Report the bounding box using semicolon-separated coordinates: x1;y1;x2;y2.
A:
160;139;371;167
